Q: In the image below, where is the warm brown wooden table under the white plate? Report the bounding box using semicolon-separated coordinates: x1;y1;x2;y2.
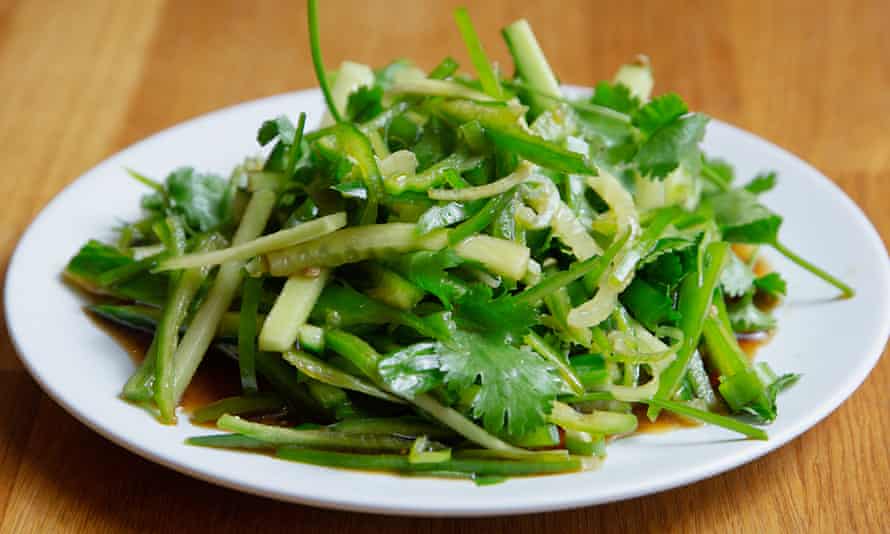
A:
0;0;890;533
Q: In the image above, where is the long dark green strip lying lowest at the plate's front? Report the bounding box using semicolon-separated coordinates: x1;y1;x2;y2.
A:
278;447;585;476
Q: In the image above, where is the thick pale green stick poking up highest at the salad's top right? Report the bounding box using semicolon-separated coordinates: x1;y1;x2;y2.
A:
501;19;562;115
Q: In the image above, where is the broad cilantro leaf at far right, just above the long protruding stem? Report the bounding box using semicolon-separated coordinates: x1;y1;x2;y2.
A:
710;189;782;244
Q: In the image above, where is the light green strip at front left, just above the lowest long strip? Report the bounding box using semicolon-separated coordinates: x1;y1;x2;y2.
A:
216;415;411;451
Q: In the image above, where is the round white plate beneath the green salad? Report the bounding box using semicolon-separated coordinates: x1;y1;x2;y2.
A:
6;91;890;516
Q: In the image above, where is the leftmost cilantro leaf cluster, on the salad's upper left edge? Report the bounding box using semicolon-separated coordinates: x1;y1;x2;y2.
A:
142;167;234;232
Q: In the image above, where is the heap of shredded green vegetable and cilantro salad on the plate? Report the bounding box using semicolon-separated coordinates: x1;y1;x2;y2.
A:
64;1;853;484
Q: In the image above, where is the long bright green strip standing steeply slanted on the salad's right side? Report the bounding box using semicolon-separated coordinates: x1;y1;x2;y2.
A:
647;242;729;421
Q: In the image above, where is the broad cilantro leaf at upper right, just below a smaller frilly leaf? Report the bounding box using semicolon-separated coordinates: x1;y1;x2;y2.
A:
634;113;708;179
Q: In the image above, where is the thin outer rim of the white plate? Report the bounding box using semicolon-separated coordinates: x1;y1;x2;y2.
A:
3;85;890;517
